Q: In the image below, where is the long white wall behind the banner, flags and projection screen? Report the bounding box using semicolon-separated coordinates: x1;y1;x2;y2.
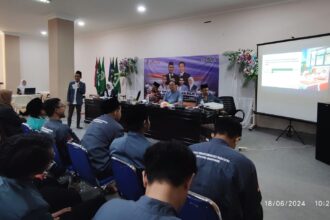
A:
75;0;330;132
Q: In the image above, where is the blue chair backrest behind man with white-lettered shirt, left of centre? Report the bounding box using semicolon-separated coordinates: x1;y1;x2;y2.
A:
67;143;99;186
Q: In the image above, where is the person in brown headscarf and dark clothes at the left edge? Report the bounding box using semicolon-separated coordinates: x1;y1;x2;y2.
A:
0;90;23;140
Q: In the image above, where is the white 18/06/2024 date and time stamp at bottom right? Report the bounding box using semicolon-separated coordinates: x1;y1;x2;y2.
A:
264;200;330;208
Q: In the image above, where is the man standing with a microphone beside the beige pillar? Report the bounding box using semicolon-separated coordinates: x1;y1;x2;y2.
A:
67;70;86;129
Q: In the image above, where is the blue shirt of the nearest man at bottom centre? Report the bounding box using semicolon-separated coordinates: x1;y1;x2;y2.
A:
94;196;180;220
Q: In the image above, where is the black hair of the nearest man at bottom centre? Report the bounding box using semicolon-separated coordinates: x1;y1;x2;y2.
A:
144;141;197;187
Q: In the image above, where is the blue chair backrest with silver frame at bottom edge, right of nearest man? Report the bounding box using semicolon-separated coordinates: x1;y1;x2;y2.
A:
179;192;222;220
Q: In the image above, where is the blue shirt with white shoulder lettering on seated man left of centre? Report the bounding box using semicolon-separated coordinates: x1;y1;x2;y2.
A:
81;114;124;174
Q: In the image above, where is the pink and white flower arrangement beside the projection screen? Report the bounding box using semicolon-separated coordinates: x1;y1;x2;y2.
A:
223;49;258;87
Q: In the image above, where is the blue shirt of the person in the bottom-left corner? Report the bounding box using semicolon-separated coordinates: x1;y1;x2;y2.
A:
0;176;53;220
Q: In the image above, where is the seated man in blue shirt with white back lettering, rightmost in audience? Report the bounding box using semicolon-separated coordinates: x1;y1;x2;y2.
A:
190;117;263;220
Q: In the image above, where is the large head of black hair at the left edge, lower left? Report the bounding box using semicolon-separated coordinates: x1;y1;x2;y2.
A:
0;134;53;179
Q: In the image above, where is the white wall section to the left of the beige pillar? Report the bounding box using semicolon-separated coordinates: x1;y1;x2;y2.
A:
20;36;49;92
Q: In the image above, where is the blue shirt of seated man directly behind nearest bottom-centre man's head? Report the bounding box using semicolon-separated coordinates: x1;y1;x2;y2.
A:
110;132;151;169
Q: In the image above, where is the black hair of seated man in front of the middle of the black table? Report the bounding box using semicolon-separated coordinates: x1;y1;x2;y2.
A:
125;105;148;132
